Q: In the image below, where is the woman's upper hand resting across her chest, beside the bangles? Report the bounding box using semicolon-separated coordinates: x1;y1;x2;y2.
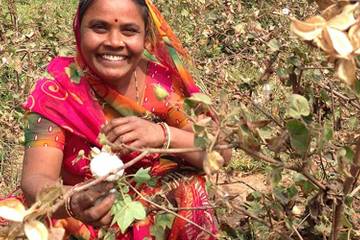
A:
102;117;164;151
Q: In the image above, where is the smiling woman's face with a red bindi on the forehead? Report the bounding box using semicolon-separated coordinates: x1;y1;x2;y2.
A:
80;0;146;85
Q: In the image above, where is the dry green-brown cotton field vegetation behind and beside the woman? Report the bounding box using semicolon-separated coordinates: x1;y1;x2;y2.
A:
0;0;360;239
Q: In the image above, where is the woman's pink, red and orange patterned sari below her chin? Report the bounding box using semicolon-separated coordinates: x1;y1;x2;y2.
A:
19;57;217;240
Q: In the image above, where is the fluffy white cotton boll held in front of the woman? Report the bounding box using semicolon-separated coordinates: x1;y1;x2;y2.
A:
90;152;124;182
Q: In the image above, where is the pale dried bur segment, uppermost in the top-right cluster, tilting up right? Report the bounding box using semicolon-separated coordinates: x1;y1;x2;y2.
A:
328;4;358;31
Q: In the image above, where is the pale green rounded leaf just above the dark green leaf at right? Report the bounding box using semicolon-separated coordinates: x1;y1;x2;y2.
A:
288;94;310;119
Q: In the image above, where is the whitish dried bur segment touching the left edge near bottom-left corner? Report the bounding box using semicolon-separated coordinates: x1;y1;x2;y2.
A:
0;198;26;222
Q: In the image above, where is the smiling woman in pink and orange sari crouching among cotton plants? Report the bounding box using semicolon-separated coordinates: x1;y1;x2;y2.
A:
22;0;230;239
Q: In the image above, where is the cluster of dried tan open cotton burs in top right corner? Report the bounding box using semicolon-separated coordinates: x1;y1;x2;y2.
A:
291;1;360;87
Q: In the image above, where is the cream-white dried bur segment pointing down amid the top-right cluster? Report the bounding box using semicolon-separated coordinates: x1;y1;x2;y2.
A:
325;27;354;58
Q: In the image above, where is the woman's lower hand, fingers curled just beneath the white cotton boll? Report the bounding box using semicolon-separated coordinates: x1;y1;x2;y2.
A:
70;183;115;227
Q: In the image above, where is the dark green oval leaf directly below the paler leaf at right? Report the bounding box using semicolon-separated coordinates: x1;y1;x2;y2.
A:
286;119;311;155
